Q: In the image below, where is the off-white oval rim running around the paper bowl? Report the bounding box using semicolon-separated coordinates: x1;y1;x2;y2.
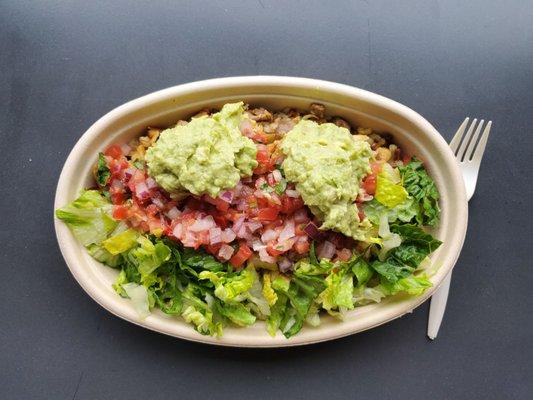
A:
53;75;468;347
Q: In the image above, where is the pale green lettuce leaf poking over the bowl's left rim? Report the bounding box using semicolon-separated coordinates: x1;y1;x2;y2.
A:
56;190;118;246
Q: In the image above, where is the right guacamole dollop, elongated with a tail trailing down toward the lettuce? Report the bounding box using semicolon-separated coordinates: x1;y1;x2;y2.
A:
281;120;372;240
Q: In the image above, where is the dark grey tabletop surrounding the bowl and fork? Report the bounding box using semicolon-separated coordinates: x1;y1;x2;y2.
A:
0;0;533;399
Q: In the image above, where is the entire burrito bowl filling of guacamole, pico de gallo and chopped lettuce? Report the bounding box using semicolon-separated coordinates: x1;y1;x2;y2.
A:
56;102;441;337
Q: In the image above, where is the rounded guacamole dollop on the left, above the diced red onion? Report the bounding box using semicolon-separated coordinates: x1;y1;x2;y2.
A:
146;102;257;197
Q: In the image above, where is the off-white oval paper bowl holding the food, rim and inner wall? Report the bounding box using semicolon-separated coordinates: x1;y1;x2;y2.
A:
54;76;467;347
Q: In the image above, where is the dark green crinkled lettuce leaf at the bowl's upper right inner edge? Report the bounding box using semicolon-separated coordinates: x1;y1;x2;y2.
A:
399;157;440;226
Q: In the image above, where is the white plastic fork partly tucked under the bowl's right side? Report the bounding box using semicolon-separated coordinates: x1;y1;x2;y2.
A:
427;118;492;340
